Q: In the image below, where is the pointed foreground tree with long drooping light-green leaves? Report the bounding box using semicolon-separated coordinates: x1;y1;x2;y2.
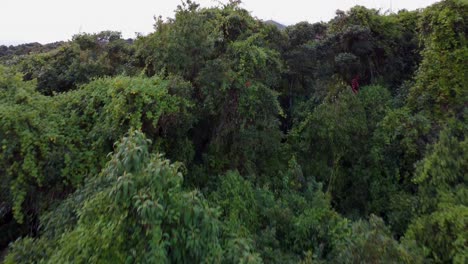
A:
7;131;260;263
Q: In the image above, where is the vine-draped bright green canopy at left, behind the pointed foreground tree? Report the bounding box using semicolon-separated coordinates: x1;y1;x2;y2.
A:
0;68;192;237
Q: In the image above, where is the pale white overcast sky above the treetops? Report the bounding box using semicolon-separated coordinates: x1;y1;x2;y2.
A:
0;0;436;44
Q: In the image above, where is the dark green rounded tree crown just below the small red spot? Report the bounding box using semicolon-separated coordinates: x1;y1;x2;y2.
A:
291;87;368;214
